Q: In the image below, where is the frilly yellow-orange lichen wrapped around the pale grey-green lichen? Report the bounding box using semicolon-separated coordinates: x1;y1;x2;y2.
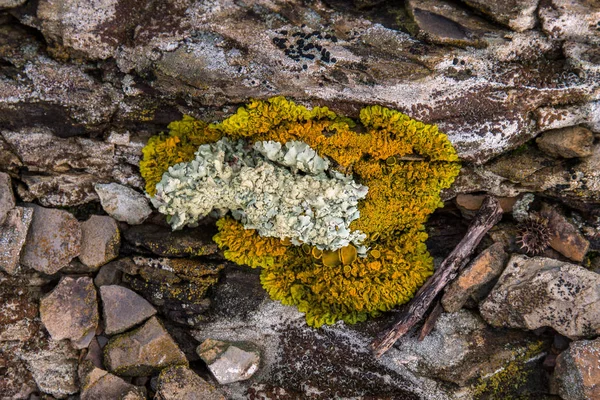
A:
141;97;460;327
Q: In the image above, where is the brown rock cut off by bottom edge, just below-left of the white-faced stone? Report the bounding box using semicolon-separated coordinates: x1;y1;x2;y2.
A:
154;365;225;400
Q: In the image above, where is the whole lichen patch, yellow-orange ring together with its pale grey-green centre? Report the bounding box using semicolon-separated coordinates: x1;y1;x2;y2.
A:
140;97;460;327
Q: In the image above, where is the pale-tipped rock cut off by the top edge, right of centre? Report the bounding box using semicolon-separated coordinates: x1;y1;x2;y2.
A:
463;0;539;32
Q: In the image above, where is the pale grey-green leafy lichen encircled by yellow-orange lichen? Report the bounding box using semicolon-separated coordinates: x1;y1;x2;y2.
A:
152;138;368;253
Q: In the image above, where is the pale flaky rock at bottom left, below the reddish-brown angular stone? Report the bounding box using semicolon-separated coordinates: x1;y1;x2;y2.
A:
23;340;79;399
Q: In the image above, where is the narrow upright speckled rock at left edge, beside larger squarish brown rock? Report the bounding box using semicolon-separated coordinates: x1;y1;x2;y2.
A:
0;207;33;275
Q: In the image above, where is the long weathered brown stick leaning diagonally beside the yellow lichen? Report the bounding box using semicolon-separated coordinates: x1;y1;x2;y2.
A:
371;196;502;357
